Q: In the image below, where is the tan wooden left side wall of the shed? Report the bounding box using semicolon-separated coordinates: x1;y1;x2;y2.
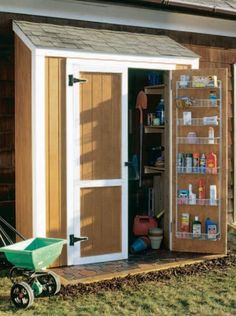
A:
15;36;33;238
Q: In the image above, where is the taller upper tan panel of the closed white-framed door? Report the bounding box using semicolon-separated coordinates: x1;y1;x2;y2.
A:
80;72;121;180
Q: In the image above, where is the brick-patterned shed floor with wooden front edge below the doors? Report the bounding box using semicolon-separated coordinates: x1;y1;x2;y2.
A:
53;250;226;285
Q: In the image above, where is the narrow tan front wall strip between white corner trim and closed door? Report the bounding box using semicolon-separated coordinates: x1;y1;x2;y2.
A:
45;58;67;266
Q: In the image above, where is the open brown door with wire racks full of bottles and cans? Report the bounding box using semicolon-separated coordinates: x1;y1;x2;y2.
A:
171;69;228;254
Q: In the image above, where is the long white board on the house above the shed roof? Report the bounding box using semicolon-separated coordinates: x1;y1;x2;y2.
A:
0;0;236;37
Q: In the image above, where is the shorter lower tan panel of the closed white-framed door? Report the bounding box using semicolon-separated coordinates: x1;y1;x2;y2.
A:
80;187;121;257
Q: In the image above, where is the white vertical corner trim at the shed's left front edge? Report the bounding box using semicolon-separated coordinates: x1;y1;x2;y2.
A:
31;52;46;237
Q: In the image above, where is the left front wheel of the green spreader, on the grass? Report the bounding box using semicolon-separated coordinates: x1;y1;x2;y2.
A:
11;282;34;308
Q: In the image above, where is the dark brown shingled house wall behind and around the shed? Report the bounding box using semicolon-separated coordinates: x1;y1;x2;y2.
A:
0;13;236;227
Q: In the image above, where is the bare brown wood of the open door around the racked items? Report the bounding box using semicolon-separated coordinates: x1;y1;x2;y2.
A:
172;69;228;253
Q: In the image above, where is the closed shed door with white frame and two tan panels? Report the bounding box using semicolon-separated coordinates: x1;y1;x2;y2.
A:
66;61;128;264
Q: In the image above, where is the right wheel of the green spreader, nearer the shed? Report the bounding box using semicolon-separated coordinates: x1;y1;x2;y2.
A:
38;271;61;296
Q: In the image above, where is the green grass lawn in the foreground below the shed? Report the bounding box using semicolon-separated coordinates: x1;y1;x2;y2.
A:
0;267;236;316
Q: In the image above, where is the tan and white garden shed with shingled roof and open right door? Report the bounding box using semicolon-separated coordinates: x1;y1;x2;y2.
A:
13;21;228;265
